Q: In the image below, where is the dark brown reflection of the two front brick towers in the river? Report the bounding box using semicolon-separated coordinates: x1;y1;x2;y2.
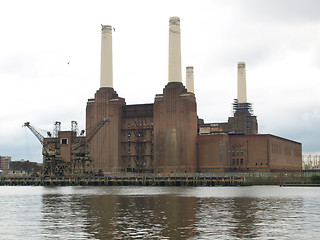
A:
89;195;196;239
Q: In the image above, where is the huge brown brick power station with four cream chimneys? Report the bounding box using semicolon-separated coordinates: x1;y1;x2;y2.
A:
85;17;302;173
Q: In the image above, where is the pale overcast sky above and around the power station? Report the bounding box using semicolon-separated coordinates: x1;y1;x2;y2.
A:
0;0;320;162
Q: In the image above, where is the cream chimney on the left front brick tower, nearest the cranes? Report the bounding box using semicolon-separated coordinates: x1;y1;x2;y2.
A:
100;25;113;88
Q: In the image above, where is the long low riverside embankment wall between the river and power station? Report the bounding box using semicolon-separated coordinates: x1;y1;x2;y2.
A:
0;171;320;186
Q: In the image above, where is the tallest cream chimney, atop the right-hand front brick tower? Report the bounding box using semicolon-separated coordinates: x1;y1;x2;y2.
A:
169;17;182;82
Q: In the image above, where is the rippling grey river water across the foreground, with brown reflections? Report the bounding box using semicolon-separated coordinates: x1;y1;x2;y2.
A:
0;186;320;239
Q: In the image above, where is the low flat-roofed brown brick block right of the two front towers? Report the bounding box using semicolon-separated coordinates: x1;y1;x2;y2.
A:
198;134;302;172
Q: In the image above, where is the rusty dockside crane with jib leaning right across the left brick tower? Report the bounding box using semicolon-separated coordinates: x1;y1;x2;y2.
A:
71;118;109;175
